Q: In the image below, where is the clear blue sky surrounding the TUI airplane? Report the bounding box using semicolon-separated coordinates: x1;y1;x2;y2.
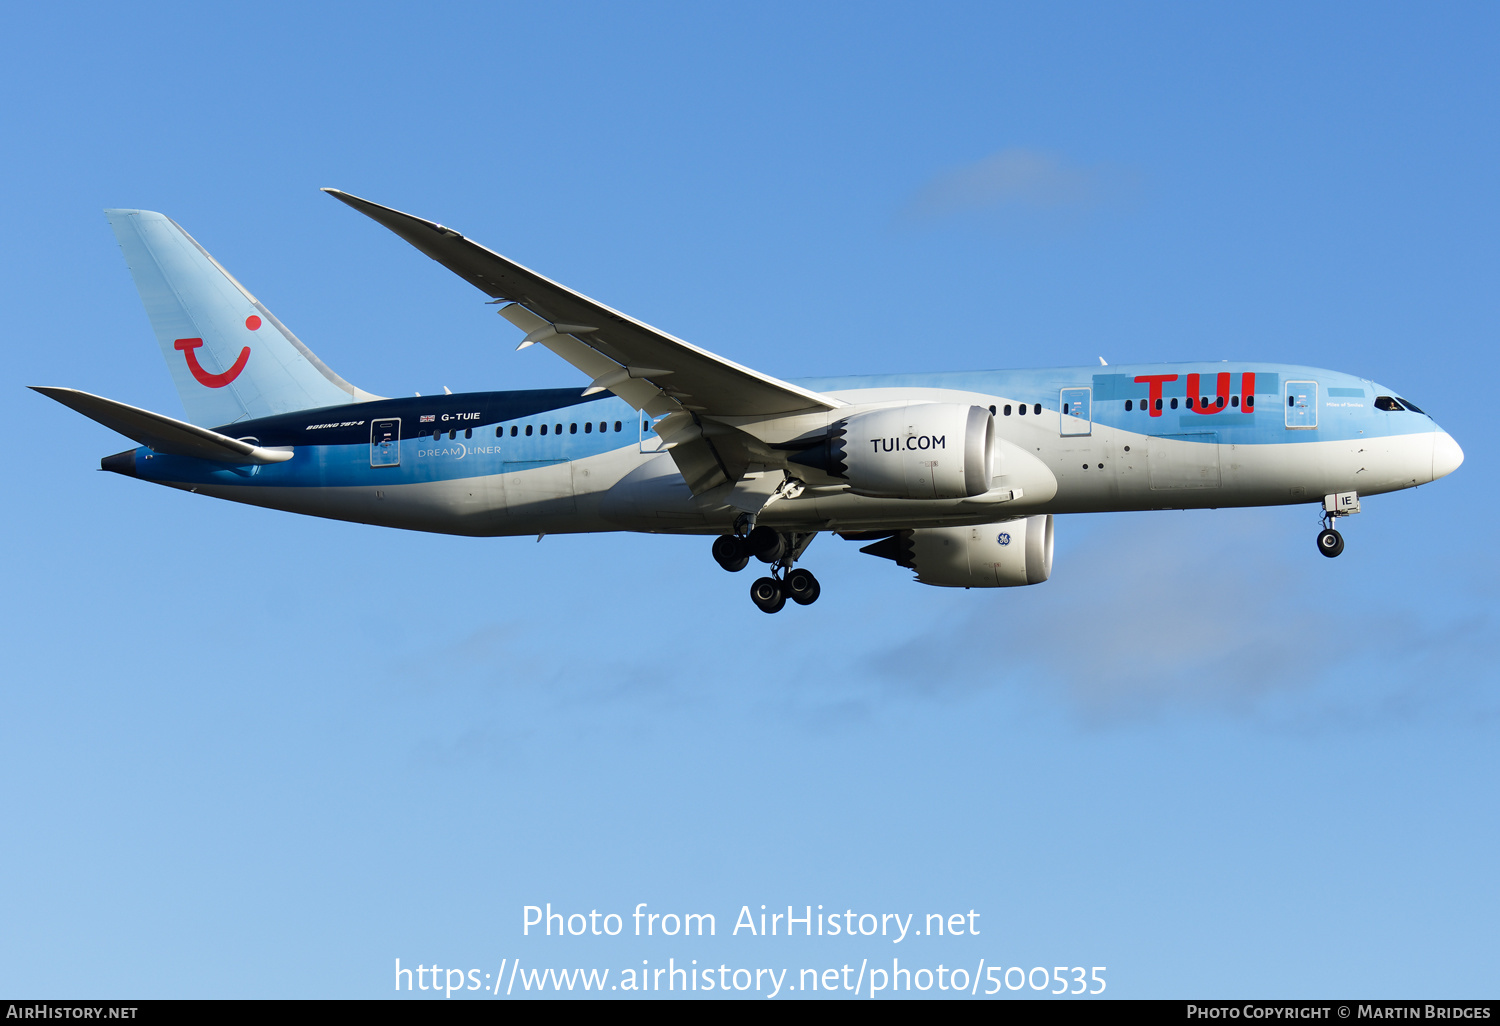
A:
0;3;1500;998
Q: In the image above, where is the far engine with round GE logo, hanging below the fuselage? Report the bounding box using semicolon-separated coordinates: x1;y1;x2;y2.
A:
860;513;1052;588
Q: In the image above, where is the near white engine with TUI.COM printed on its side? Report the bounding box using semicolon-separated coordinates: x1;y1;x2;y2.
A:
791;402;995;500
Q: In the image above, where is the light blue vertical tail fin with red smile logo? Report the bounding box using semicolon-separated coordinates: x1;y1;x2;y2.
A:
105;210;380;426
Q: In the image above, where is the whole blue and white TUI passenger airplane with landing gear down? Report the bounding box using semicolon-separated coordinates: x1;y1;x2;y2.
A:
35;189;1464;614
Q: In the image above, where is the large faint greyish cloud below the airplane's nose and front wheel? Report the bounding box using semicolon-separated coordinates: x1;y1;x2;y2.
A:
863;510;1496;731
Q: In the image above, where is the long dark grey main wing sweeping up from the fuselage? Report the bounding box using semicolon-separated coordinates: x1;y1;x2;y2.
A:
324;189;845;422
